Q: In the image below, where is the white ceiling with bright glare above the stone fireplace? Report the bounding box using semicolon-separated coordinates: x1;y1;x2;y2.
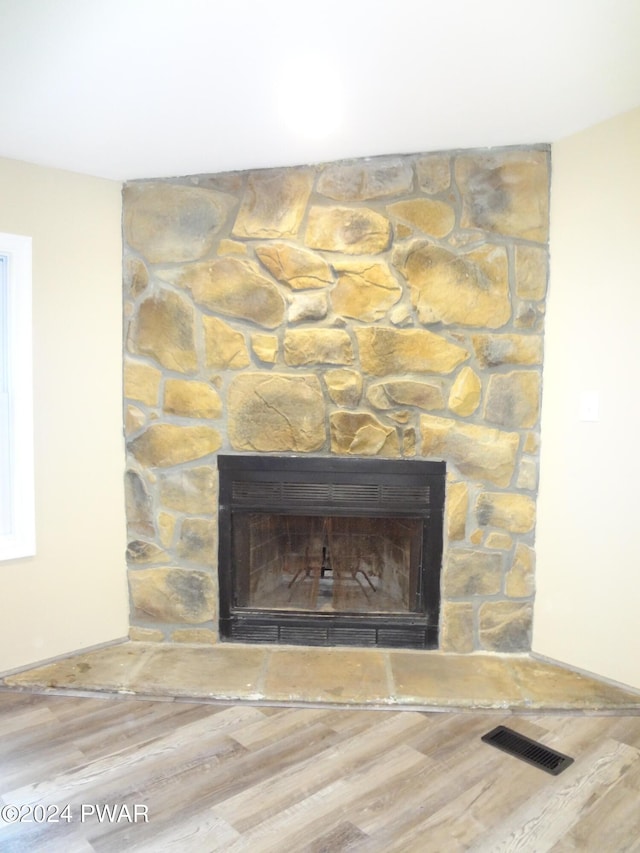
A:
0;0;640;180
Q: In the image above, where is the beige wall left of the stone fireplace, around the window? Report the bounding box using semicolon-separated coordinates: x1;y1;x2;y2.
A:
0;160;128;671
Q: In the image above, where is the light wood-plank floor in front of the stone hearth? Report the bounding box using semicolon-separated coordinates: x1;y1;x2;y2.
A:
0;691;640;853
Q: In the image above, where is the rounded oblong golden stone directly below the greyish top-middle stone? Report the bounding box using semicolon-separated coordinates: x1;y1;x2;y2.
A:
305;207;391;255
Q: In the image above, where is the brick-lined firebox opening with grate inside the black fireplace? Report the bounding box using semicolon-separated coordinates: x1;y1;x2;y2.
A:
233;513;422;613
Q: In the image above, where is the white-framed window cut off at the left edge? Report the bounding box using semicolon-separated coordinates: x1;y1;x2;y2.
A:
0;233;36;560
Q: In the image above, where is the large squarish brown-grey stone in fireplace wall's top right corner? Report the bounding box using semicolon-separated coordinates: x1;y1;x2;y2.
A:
455;150;549;243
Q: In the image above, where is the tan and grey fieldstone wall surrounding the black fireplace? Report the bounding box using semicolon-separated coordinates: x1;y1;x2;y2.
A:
123;147;549;652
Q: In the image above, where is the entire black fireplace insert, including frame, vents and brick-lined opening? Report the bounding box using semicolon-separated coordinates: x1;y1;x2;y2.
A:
218;454;445;649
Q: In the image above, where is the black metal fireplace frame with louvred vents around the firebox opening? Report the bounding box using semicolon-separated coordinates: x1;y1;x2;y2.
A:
218;454;446;649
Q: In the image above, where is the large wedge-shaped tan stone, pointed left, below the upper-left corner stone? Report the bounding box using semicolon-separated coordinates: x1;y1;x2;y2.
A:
157;257;285;329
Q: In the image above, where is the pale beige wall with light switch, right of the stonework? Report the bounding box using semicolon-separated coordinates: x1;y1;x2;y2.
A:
533;110;640;688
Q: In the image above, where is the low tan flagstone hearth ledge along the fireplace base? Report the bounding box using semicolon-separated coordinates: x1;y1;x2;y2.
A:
0;642;640;714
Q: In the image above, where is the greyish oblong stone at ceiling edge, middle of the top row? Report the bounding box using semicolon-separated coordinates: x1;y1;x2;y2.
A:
317;157;413;201
